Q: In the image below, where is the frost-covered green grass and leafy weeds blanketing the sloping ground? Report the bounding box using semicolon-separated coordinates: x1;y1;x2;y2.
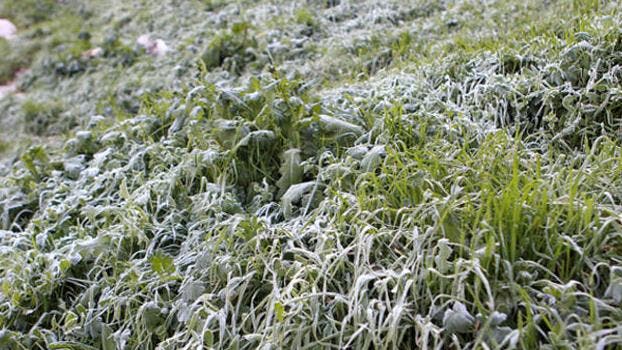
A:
0;0;622;349
